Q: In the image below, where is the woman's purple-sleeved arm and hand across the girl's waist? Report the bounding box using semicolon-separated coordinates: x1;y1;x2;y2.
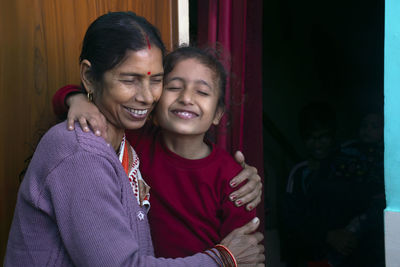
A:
47;152;263;267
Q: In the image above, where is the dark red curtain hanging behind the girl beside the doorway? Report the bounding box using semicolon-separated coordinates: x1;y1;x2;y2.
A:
197;0;264;224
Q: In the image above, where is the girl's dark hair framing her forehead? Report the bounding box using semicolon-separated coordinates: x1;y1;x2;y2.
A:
164;46;227;108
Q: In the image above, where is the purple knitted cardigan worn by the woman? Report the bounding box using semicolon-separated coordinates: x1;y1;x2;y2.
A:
4;122;217;267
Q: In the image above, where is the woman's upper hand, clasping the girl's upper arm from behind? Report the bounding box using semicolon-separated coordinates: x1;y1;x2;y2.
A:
229;151;262;211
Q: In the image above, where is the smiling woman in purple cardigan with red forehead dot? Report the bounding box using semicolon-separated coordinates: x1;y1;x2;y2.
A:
5;12;264;266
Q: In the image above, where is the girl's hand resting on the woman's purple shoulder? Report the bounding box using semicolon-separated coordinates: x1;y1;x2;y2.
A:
66;94;107;138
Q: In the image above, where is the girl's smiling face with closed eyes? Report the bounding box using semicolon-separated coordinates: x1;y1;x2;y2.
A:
156;58;223;136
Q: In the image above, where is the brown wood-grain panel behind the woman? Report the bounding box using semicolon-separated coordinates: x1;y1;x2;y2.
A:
0;0;177;262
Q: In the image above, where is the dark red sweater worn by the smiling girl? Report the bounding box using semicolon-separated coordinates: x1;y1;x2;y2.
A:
53;86;256;258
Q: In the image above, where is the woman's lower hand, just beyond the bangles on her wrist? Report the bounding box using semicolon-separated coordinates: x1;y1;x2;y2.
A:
221;218;265;267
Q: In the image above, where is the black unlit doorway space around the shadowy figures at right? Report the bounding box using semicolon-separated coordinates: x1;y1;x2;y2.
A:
189;0;384;264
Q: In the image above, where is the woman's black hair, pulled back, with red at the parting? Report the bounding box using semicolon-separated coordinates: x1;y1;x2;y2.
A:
79;11;165;81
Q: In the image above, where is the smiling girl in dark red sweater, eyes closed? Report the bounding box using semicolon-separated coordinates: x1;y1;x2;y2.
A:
53;47;255;257
